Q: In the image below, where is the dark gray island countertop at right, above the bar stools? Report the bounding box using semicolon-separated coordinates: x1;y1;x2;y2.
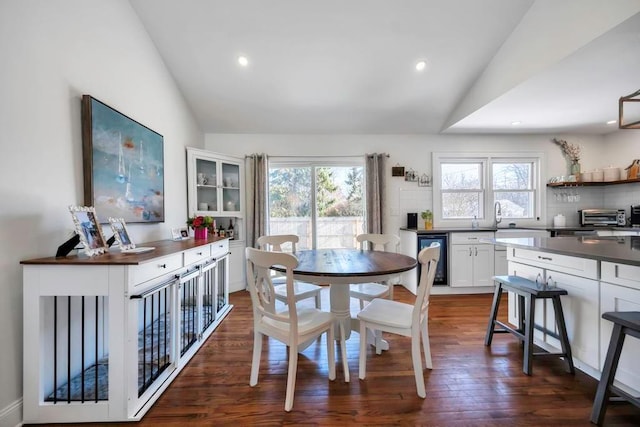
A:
486;236;640;266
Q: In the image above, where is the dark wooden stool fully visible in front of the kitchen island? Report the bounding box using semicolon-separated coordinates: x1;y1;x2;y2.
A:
484;276;575;375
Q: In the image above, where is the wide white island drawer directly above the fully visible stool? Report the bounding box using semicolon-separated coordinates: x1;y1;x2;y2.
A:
507;248;598;279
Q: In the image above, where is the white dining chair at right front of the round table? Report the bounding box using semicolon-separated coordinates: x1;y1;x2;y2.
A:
358;243;440;398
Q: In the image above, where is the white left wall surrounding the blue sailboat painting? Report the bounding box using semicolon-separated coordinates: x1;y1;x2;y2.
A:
0;0;204;426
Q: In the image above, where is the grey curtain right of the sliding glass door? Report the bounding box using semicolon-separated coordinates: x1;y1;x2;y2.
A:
365;153;389;233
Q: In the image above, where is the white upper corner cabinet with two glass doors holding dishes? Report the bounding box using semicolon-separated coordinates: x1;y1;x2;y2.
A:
187;147;244;218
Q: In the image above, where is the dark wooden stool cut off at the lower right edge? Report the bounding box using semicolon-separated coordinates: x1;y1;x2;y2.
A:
591;311;640;425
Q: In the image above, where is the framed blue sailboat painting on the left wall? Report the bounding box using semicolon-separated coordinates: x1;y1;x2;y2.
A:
82;95;164;223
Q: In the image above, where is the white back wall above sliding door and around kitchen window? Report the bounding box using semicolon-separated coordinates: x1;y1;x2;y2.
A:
205;134;603;230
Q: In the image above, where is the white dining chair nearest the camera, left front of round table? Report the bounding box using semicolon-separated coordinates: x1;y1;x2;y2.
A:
245;248;348;412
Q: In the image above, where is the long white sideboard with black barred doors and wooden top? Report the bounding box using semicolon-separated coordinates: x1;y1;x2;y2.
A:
21;238;232;423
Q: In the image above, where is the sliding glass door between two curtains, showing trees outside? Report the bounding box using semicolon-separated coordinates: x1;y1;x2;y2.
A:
268;158;364;249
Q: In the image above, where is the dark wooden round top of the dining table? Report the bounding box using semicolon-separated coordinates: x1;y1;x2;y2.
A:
274;249;417;278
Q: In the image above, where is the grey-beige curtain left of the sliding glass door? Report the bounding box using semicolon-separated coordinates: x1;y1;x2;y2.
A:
245;154;269;248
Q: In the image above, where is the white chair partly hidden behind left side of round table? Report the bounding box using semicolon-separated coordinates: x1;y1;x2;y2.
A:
257;234;322;309
